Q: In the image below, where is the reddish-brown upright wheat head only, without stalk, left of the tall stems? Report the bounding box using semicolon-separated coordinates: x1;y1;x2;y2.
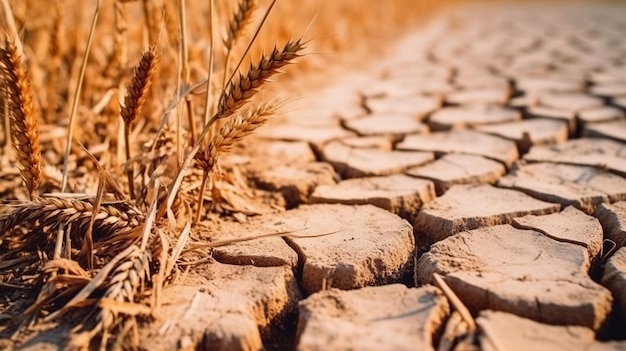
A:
120;46;159;126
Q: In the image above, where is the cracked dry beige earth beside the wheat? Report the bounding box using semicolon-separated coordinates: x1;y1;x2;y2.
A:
11;3;626;351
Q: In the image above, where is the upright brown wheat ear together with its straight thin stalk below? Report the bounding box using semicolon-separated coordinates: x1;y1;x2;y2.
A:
120;46;159;199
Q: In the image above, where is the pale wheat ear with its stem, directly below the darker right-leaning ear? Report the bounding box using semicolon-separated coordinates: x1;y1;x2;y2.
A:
194;104;277;223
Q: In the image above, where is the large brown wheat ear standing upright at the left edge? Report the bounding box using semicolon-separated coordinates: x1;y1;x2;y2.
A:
0;37;43;200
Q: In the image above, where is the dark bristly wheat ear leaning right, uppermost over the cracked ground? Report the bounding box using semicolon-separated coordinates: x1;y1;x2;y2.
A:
214;39;305;119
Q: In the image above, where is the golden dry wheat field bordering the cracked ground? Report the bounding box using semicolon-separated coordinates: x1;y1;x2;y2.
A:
0;0;439;349
